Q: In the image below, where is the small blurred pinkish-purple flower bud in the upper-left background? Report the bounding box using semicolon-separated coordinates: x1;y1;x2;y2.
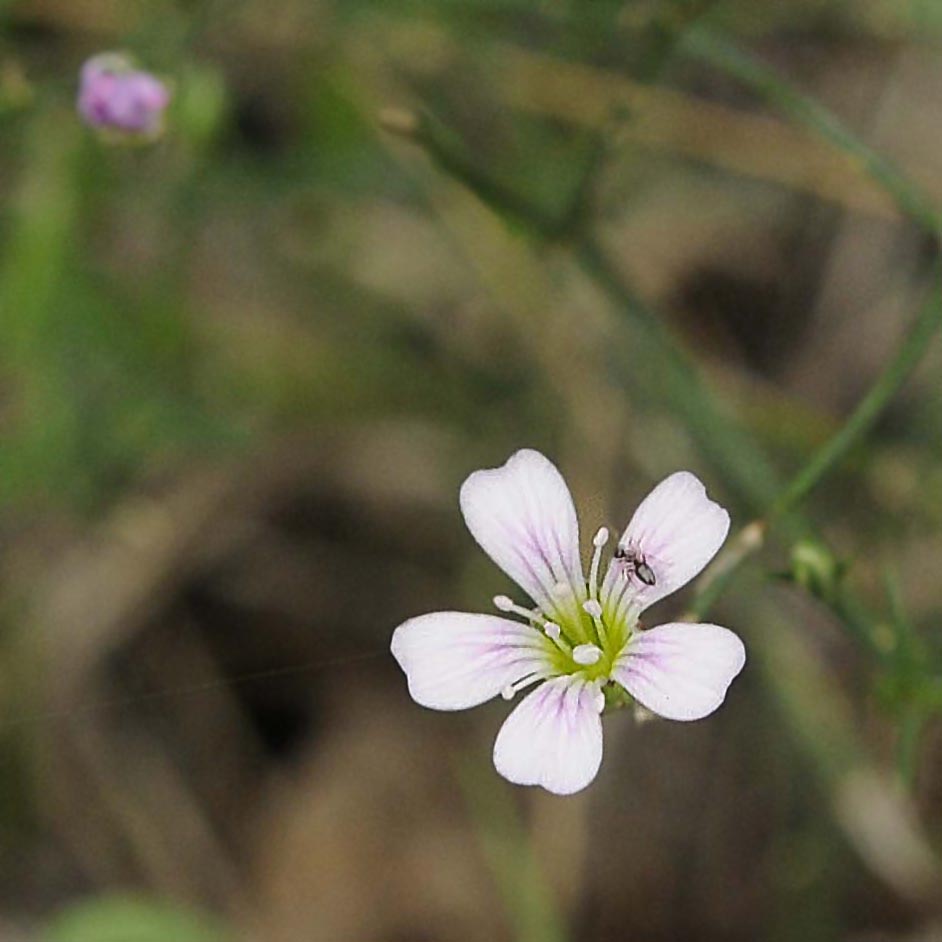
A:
77;52;170;139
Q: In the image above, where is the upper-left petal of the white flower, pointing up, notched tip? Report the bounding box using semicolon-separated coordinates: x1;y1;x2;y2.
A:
461;448;586;615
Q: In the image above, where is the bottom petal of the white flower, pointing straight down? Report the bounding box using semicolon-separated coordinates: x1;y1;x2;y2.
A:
494;676;604;795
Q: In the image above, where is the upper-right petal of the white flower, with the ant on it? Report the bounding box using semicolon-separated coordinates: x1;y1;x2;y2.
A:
602;471;729;612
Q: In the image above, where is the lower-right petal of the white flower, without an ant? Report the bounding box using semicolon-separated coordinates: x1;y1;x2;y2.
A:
612;623;746;720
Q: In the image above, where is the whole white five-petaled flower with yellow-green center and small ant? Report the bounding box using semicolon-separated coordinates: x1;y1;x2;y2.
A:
392;449;746;795
